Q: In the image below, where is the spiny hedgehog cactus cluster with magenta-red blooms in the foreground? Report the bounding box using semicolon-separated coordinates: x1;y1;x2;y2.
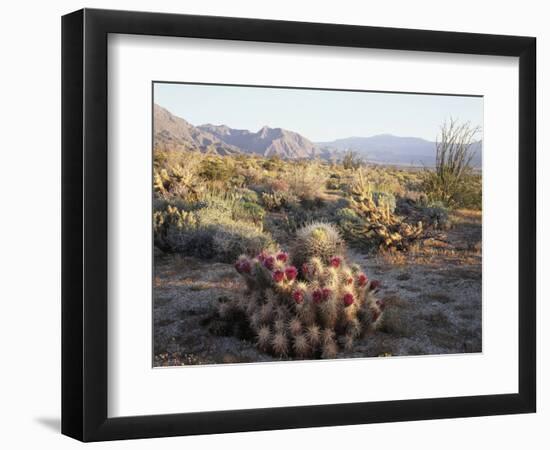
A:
223;246;384;358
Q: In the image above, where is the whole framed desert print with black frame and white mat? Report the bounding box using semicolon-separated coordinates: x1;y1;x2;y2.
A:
62;9;536;441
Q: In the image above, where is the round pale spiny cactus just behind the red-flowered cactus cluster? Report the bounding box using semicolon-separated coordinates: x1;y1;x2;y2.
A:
293;222;346;267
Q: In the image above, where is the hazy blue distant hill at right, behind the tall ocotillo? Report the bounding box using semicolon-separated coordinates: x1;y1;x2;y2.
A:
317;134;482;166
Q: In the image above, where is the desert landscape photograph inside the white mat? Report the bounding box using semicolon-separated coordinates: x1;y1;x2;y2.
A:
151;82;483;367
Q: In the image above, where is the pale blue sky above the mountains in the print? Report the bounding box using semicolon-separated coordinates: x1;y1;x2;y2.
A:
154;83;483;142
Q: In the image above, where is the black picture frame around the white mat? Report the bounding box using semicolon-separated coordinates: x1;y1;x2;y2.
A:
62;9;536;441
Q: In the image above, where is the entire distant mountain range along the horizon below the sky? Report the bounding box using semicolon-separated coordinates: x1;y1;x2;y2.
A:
154;104;482;167
